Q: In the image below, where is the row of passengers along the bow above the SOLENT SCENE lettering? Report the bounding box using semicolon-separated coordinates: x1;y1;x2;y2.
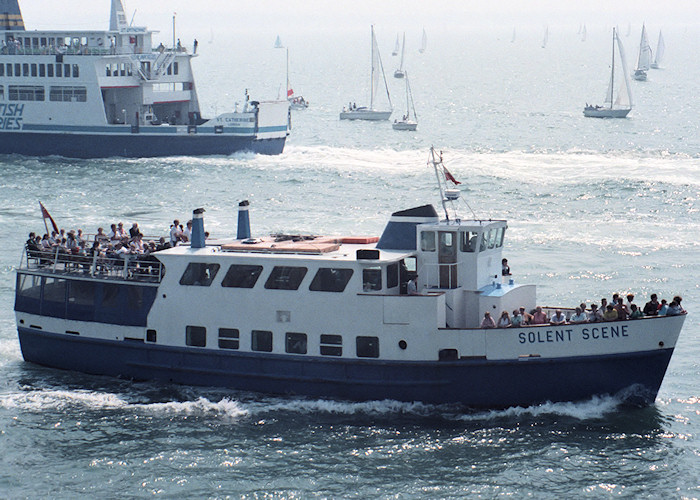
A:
481;293;686;328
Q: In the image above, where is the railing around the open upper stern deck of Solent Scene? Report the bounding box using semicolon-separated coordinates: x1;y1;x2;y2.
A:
19;247;165;283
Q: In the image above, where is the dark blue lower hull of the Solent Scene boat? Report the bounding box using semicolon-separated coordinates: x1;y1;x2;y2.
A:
18;327;673;409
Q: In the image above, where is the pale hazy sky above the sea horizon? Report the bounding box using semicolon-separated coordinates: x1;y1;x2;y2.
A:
20;0;700;37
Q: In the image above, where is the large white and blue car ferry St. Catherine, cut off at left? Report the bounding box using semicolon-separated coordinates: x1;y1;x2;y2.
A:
0;0;290;158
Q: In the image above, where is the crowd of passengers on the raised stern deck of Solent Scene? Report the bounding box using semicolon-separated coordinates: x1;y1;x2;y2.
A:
26;219;202;266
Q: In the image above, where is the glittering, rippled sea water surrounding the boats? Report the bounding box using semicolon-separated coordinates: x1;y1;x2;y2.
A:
0;22;700;498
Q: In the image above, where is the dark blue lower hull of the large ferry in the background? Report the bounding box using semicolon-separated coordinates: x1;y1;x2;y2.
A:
0;132;286;159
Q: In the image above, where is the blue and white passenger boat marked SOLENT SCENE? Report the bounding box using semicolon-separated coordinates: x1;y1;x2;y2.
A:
15;150;685;408
